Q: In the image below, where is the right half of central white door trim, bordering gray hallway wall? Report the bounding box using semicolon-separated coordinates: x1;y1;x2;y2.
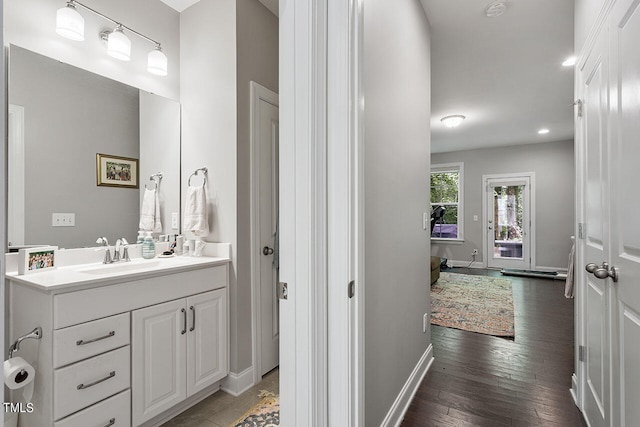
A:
326;0;364;427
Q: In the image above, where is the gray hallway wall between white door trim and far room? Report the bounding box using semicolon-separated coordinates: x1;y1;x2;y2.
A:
364;0;431;426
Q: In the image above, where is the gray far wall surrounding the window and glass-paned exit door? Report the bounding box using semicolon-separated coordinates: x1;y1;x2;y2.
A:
431;141;574;270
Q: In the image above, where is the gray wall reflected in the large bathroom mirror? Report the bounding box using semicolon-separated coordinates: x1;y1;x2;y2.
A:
9;46;140;248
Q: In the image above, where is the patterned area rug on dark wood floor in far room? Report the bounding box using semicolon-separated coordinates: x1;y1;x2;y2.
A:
431;272;515;337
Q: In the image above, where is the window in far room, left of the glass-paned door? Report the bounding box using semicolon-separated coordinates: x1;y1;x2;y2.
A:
430;163;464;240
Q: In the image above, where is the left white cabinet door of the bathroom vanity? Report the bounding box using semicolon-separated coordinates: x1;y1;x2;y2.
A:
131;299;187;425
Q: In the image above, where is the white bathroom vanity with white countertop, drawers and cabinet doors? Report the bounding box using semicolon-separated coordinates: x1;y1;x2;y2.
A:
7;247;230;427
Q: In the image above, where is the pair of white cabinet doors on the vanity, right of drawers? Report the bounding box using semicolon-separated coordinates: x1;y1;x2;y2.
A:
131;289;227;425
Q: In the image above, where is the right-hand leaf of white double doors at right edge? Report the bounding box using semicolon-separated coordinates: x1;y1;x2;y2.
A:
608;0;640;427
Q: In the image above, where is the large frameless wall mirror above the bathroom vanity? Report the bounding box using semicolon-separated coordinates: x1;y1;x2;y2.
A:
7;45;180;249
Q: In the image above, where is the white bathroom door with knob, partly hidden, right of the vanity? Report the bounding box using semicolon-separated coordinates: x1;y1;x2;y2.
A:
251;82;280;376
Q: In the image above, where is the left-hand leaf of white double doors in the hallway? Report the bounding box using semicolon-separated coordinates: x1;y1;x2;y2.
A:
576;25;612;427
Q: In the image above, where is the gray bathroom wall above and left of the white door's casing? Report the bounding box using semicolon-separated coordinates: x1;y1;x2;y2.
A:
236;0;278;370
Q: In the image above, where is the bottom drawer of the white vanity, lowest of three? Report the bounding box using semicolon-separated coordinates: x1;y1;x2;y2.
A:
53;390;131;427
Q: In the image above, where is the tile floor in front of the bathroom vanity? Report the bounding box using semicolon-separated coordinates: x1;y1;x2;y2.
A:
162;368;280;427
